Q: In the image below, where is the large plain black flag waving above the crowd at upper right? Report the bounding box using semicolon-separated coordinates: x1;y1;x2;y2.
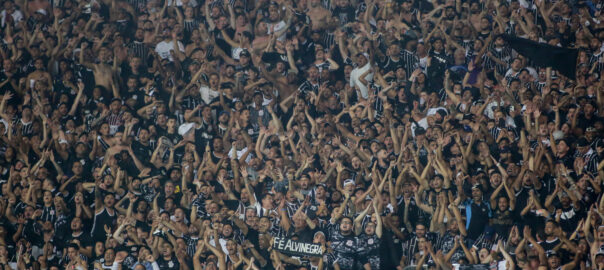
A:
503;35;579;80
